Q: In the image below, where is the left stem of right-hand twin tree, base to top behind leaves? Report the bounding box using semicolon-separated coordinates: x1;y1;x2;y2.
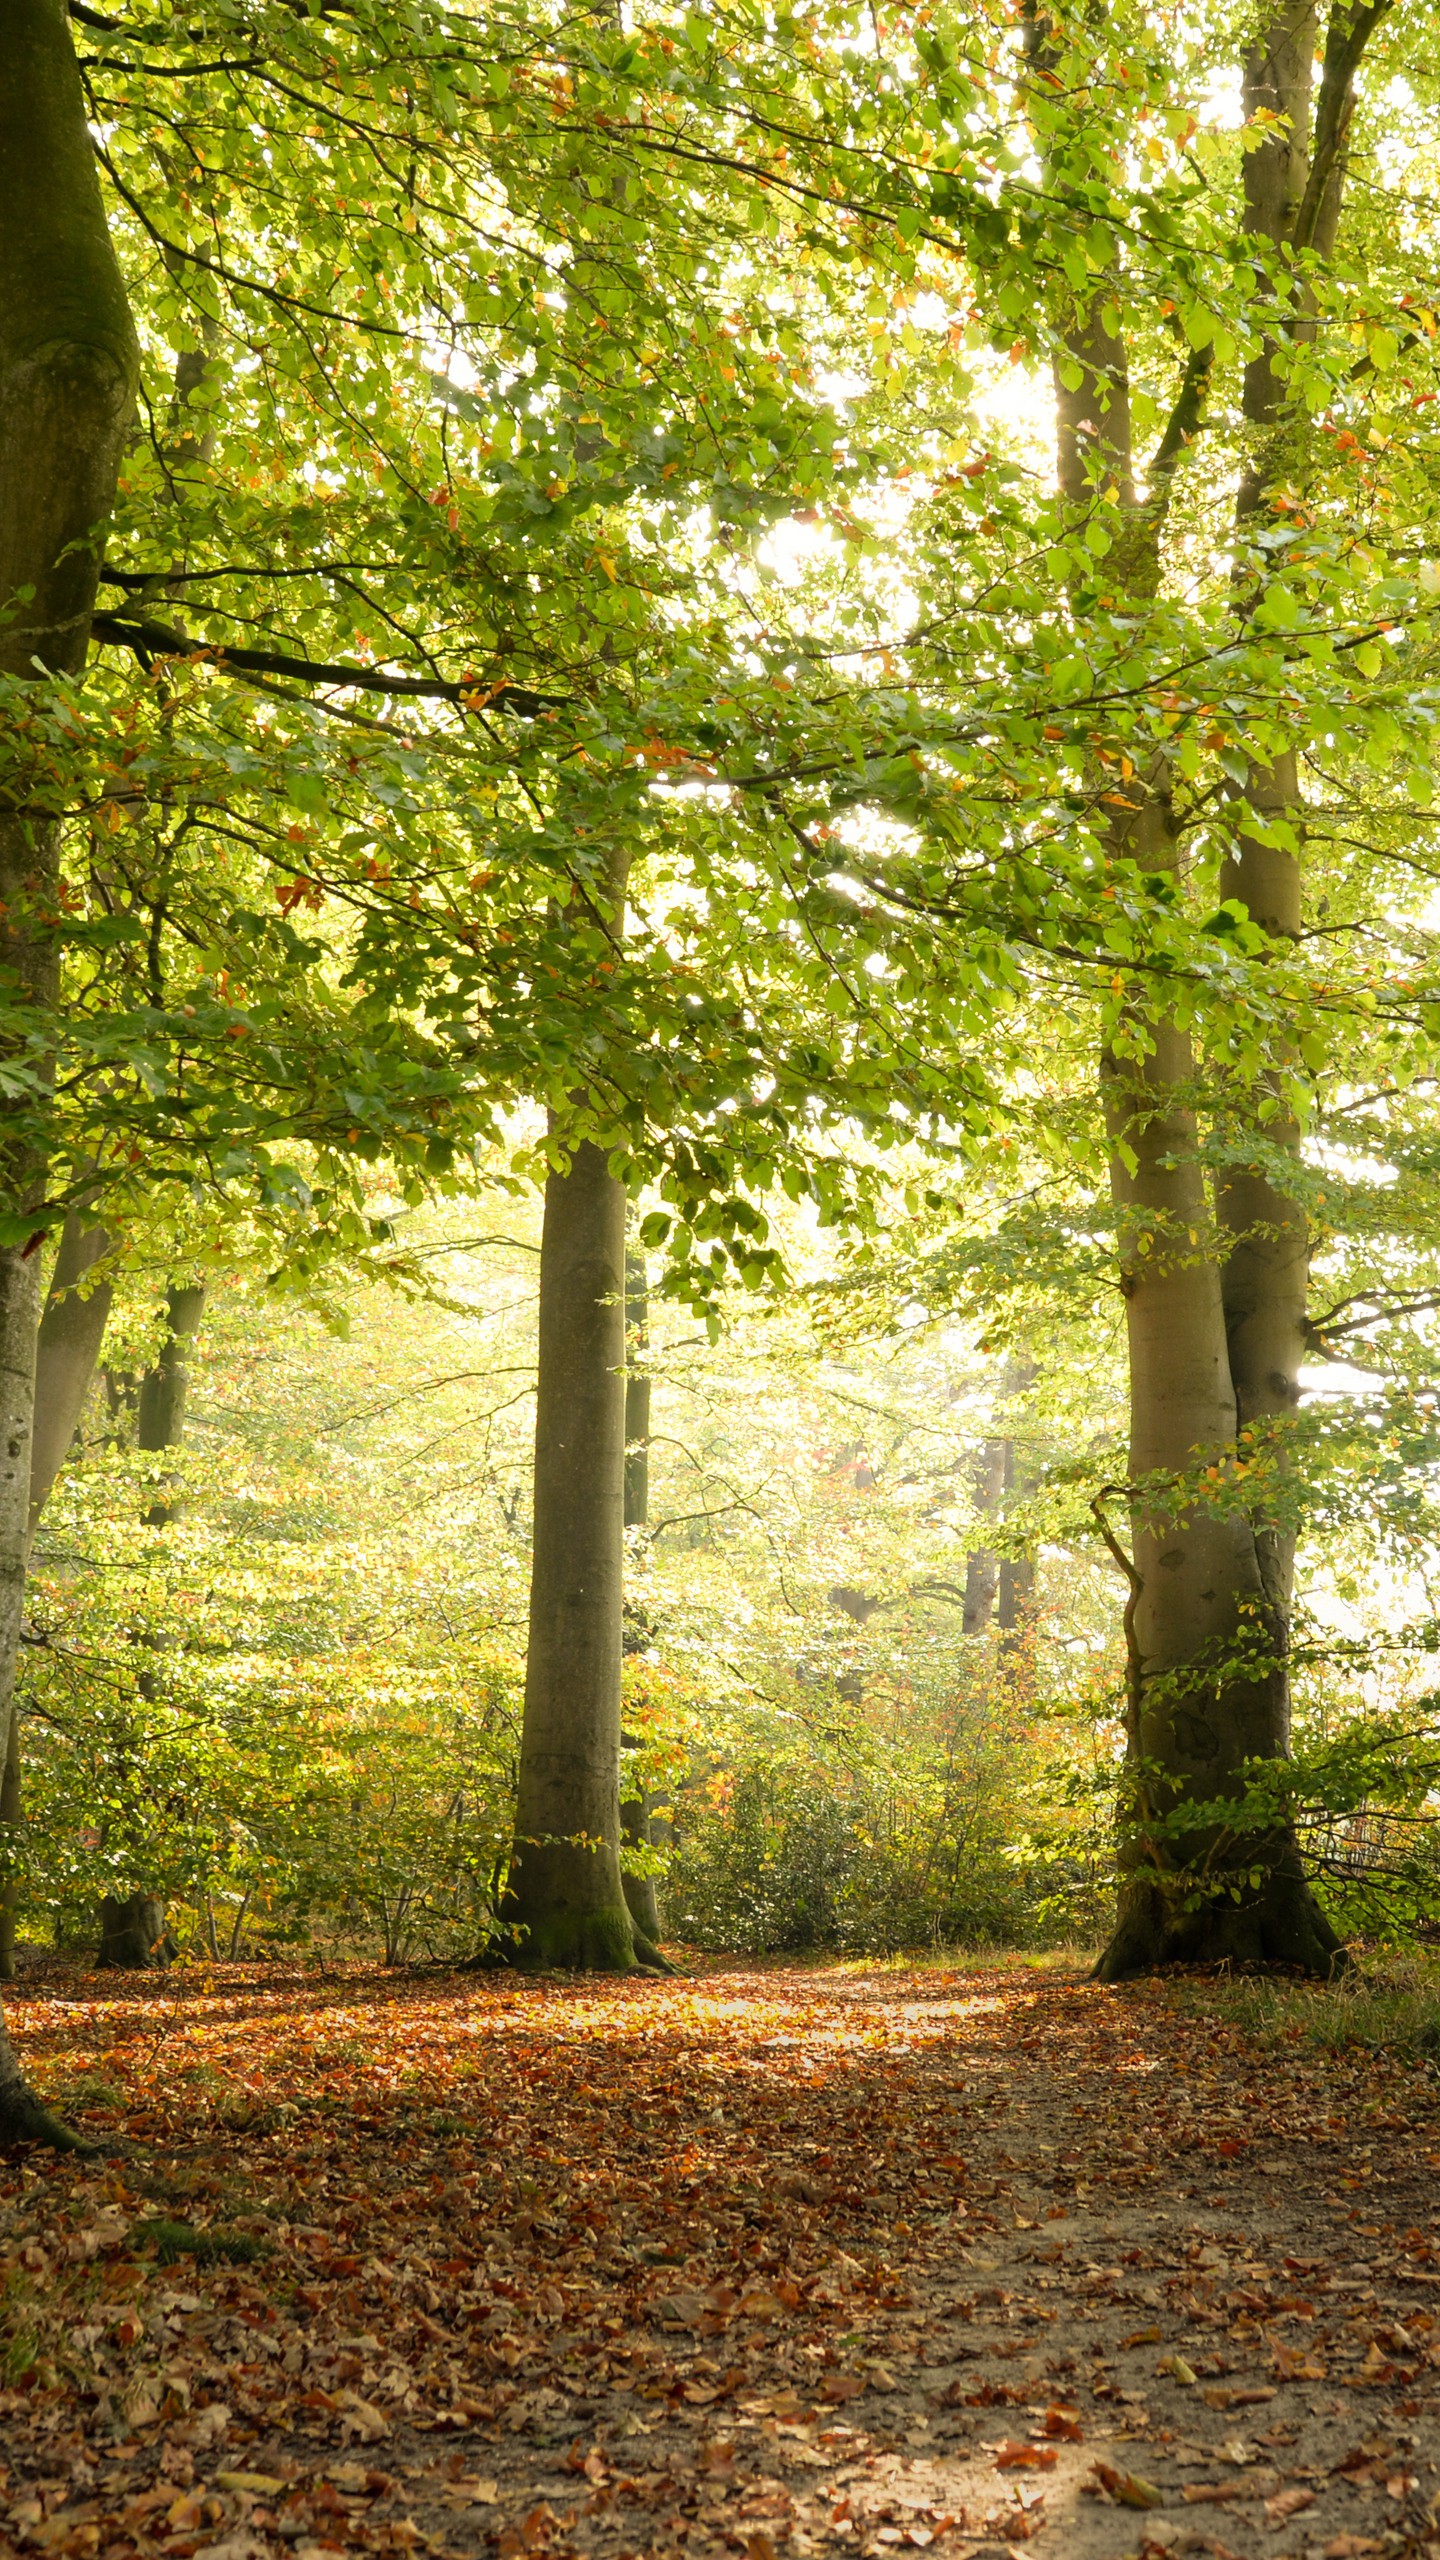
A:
1030;0;1338;1981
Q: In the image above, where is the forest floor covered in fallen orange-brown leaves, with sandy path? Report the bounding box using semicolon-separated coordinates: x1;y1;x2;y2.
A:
0;1961;1440;2560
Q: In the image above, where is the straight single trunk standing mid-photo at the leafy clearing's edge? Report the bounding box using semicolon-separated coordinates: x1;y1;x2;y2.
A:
502;1139;659;1971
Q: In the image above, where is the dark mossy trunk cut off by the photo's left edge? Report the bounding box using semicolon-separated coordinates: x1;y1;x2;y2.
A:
0;0;138;2140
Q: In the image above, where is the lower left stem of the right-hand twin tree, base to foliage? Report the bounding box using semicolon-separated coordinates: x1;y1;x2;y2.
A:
1097;988;1338;1981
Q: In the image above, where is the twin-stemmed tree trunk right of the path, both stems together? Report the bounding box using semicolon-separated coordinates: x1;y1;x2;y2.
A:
1027;0;1384;1981
